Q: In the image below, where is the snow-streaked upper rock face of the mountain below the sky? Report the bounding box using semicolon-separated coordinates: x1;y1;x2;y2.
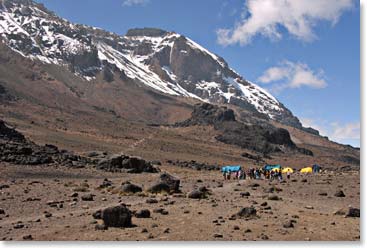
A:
0;0;317;133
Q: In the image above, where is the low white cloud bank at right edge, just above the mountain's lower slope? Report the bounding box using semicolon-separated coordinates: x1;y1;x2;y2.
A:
301;118;361;147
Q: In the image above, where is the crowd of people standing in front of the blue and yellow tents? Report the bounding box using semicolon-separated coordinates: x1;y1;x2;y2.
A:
223;168;291;181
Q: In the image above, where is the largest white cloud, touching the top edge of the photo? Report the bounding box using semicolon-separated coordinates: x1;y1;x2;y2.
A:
217;0;354;45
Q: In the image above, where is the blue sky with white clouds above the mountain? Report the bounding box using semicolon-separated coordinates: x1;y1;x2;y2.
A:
37;0;360;146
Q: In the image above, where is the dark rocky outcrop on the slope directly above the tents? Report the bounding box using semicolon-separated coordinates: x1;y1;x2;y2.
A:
174;103;313;156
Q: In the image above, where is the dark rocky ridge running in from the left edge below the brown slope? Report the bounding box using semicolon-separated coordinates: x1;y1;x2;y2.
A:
0;120;159;173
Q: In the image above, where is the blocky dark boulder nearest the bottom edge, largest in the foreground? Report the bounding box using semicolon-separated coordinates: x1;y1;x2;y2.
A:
101;205;132;227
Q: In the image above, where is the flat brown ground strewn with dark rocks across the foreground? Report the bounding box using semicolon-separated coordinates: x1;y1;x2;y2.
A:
0;163;360;240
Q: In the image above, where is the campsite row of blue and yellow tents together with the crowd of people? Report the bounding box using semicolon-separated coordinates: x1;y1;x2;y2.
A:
221;164;321;181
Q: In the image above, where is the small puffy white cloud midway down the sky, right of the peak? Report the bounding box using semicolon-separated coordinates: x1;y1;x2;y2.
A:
257;60;327;93
